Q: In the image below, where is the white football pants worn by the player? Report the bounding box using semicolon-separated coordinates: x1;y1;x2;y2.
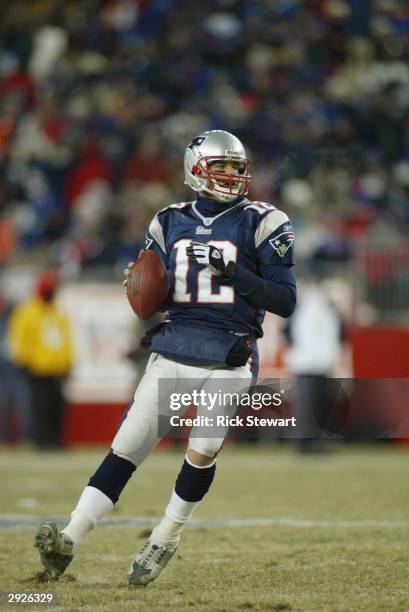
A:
112;353;251;466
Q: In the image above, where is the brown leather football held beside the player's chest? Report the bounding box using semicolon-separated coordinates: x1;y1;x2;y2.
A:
126;251;169;320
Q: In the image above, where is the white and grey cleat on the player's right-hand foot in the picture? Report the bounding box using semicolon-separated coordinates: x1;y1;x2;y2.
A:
128;538;177;586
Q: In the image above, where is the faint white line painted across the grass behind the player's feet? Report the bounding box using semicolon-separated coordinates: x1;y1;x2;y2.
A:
0;515;409;529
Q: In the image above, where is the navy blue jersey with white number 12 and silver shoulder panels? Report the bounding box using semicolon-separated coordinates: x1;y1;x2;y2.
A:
146;198;295;337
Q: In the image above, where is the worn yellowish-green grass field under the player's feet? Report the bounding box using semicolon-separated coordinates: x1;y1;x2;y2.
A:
0;445;409;612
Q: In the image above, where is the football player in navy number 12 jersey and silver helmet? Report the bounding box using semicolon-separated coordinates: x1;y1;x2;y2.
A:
35;130;296;585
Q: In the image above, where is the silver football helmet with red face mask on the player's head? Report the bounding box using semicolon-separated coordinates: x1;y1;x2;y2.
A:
184;130;251;202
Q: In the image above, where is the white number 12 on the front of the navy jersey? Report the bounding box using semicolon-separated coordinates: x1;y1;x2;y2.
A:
173;238;237;304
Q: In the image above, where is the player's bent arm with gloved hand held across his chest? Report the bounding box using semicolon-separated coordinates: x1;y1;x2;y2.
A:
187;210;297;317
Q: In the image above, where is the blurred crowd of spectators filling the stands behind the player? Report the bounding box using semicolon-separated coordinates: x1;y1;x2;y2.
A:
0;0;409;276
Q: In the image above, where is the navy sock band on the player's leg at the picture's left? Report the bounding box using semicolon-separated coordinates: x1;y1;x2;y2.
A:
88;452;136;504
